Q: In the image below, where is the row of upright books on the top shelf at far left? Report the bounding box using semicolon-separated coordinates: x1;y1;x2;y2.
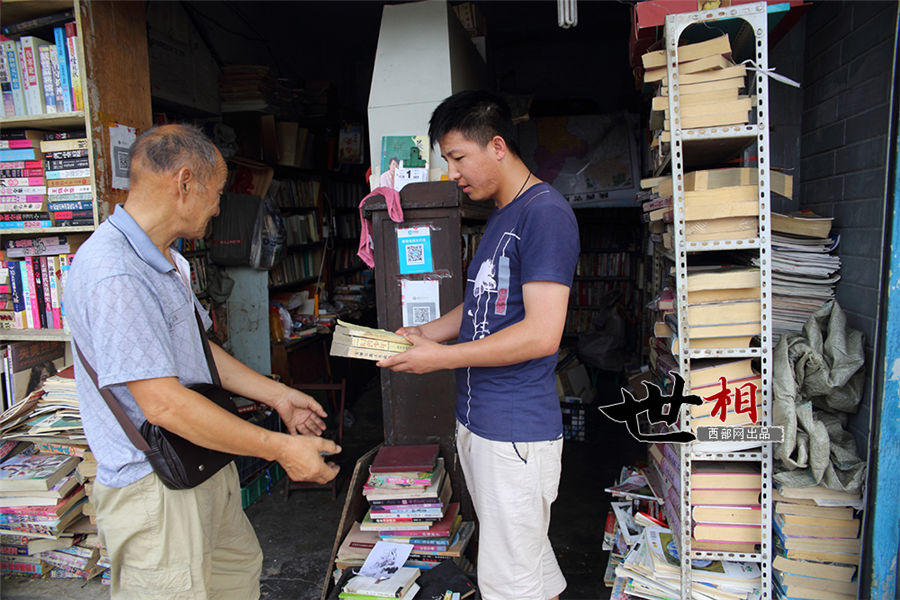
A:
0;14;84;117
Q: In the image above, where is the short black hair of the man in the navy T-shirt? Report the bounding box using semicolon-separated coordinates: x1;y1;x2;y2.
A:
428;90;521;156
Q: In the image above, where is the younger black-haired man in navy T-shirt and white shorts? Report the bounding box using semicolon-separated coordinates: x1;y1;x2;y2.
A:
378;91;579;600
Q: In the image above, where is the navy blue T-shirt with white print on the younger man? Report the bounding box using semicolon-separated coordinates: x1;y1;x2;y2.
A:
456;183;579;442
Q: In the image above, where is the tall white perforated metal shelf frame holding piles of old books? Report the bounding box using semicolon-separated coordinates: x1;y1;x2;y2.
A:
665;2;772;599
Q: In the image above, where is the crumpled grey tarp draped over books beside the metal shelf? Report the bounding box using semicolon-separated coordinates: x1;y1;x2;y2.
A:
772;300;866;493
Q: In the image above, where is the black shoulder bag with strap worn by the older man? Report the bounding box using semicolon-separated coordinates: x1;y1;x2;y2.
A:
72;307;238;490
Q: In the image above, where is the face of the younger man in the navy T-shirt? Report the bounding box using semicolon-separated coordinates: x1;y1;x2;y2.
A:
439;131;500;200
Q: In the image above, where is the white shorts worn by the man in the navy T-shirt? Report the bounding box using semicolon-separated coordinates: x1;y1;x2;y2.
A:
456;422;566;600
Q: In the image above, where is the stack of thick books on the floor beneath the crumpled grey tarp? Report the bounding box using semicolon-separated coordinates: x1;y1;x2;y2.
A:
772;484;862;600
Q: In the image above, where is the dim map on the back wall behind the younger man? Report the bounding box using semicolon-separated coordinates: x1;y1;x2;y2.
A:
519;113;639;204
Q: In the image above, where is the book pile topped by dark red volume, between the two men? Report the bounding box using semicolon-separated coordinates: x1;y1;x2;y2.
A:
336;444;475;569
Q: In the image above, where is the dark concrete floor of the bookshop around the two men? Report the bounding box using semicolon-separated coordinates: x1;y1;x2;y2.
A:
0;378;646;600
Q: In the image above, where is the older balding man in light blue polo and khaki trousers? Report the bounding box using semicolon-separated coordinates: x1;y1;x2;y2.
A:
66;125;340;600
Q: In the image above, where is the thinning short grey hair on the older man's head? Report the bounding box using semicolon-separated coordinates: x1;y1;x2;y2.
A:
129;124;221;189
